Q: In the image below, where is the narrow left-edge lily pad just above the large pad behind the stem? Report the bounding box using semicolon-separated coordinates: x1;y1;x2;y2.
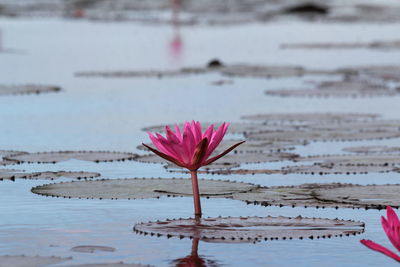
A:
0;169;100;181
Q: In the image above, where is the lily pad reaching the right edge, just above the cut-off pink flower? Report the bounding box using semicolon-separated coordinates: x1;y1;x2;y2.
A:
232;183;400;209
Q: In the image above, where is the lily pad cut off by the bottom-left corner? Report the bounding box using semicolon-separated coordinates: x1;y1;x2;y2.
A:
0;255;72;267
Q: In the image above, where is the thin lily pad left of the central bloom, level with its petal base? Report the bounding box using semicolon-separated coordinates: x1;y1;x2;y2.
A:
5;151;136;163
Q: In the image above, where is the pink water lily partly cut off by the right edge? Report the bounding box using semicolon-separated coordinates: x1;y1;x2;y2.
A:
360;206;400;262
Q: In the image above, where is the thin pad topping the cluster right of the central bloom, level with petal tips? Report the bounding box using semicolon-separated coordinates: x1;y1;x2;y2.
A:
242;113;379;125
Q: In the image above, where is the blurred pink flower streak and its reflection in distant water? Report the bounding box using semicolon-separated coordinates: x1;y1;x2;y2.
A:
169;0;183;63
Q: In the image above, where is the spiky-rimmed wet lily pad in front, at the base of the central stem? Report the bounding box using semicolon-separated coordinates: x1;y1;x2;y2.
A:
133;216;364;243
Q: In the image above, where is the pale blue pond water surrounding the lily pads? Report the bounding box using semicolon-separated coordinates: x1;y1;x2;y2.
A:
0;18;400;266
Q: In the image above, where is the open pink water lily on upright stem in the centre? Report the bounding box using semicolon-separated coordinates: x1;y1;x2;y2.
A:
143;121;244;216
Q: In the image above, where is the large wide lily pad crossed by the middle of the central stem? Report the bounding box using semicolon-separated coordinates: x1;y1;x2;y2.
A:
31;178;258;199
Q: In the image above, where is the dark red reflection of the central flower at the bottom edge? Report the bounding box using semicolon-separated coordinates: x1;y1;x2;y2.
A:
172;238;221;267
